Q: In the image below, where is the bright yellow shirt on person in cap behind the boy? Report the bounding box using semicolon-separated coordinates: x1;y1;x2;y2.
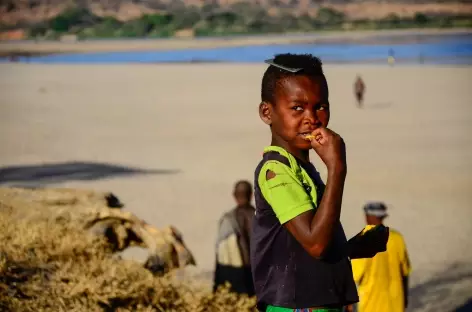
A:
351;229;411;312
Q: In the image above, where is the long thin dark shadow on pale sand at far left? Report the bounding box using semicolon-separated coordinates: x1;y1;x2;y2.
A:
0;162;179;186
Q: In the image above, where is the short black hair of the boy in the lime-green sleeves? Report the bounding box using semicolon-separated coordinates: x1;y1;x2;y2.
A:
261;53;324;104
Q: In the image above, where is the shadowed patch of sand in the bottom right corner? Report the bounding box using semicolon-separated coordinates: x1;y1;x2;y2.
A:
408;264;472;312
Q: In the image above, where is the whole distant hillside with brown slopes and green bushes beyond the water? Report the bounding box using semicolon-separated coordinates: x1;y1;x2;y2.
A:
0;0;472;39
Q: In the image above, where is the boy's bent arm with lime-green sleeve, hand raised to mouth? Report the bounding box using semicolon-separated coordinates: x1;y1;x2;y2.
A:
269;128;346;258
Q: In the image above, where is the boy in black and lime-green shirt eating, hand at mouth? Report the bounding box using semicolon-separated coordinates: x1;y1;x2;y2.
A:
251;54;388;312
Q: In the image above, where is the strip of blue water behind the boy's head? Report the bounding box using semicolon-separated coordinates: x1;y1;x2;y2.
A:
0;34;472;64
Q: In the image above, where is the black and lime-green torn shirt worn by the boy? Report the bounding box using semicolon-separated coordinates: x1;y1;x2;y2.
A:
251;146;359;311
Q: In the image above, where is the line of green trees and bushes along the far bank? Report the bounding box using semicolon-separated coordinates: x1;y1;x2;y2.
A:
4;3;472;39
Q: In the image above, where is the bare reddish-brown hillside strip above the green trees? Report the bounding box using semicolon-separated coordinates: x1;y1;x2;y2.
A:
0;0;472;26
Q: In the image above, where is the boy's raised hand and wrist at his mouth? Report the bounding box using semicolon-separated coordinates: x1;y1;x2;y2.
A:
310;128;346;172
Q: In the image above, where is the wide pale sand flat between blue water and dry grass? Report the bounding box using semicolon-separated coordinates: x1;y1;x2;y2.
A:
0;64;472;311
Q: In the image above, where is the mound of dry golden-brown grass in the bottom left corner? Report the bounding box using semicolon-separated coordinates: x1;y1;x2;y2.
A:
0;203;255;312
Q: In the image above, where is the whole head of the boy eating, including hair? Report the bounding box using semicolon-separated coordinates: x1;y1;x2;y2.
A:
259;54;329;156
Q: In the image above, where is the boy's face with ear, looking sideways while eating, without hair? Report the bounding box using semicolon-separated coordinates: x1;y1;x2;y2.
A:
259;76;329;152
